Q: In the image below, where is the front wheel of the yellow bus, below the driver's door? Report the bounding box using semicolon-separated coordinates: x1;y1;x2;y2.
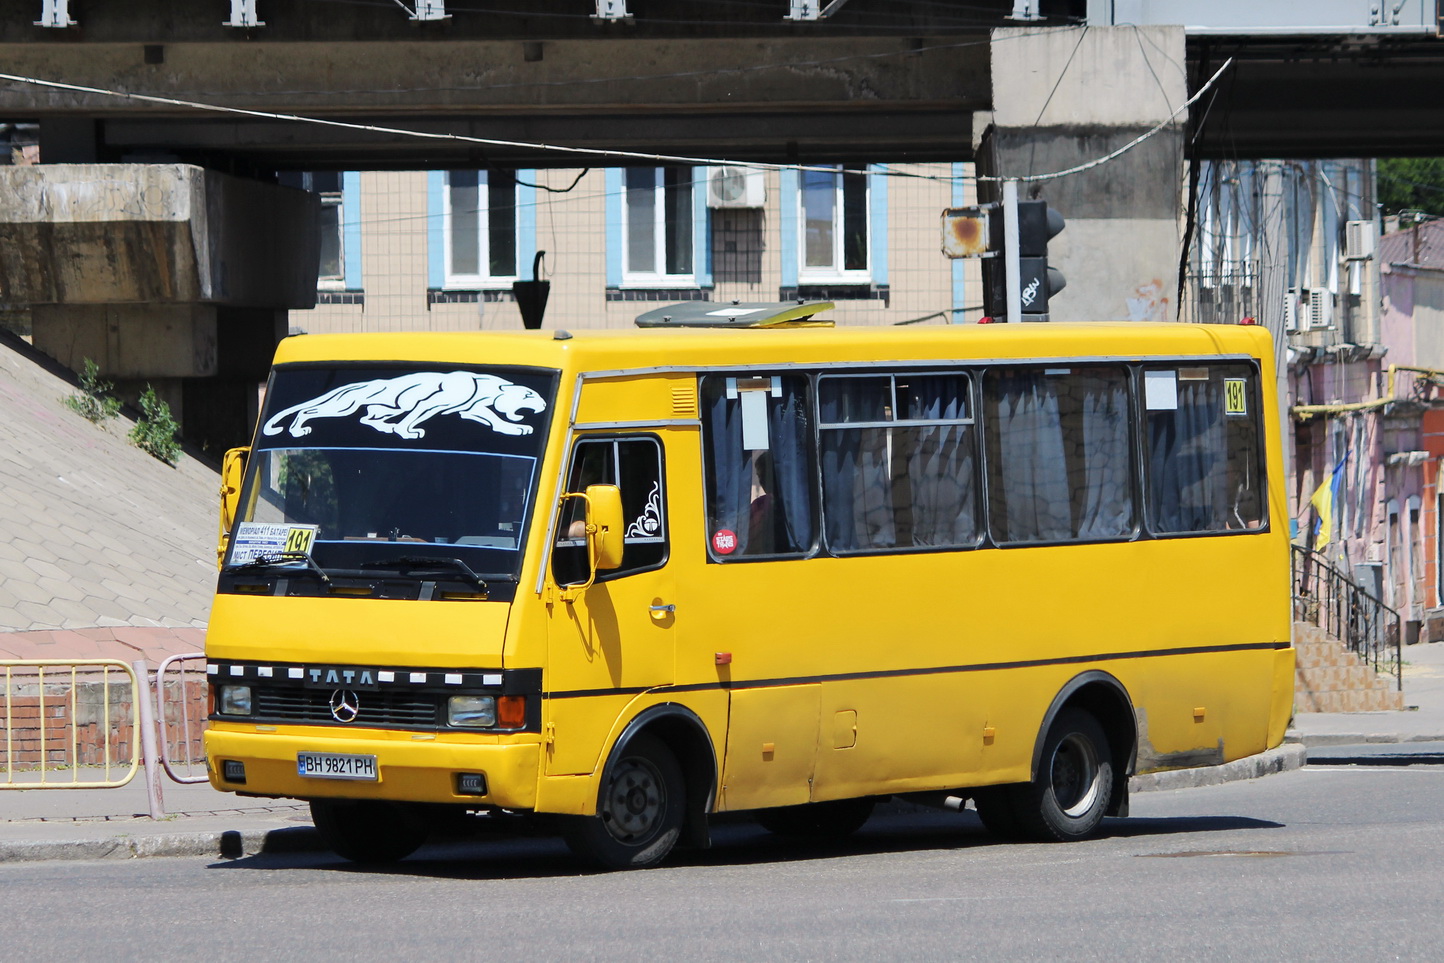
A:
565;733;687;869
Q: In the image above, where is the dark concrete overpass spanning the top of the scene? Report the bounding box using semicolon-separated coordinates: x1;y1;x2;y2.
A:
0;0;1444;166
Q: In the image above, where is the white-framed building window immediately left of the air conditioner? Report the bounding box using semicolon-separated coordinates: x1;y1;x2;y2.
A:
622;167;697;286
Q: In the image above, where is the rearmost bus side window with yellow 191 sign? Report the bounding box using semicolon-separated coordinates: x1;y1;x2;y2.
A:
1144;364;1264;534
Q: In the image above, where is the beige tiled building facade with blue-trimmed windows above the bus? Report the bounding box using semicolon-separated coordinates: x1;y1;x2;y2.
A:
287;165;982;334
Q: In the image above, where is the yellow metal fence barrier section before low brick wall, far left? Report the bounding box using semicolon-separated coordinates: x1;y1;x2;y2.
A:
0;658;146;790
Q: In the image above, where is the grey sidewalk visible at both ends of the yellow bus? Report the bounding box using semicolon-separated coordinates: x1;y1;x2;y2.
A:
0;642;1444;862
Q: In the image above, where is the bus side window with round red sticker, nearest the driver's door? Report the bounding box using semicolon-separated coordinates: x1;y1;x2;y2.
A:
702;374;817;562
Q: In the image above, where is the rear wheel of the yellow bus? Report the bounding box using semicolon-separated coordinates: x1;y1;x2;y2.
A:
1008;709;1113;842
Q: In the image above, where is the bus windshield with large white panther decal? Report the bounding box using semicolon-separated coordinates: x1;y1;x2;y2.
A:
227;365;554;578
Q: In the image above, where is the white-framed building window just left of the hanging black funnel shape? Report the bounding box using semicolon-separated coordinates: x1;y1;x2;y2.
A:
445;170;518;287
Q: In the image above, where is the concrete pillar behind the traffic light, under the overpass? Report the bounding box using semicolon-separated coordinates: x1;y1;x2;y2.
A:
978;27;1188;321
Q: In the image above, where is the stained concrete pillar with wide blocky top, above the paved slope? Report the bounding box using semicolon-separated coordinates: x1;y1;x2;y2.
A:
0;163;319;453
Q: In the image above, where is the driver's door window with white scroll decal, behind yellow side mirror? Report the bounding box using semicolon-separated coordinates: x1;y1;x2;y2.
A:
552;436;667;585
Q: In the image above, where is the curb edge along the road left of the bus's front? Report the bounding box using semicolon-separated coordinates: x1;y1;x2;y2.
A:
0;826;325;863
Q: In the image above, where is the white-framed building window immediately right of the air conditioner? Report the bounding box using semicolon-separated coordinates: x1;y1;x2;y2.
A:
799;167;871;282
